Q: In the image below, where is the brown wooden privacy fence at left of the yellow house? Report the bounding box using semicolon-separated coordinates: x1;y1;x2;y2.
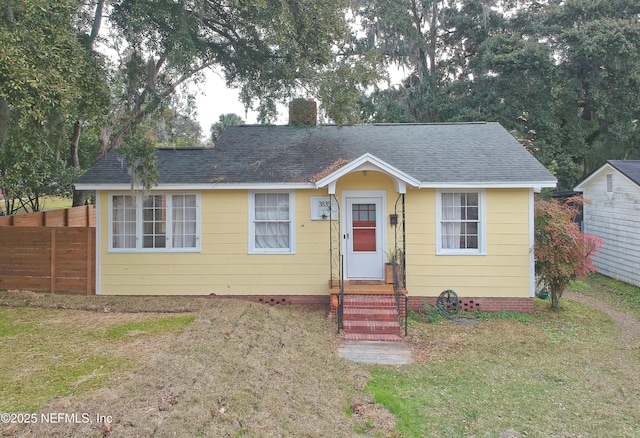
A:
0;207;96;295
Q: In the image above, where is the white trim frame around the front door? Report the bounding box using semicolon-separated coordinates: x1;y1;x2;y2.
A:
341;190;387;280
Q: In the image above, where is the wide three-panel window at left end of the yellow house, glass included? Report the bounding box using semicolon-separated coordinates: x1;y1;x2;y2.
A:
109;193;200;252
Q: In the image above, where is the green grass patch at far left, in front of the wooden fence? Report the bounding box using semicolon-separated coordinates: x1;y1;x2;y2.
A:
0;307;194;412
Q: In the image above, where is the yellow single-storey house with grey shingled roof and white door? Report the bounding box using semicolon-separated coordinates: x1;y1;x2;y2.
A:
76;123;556;338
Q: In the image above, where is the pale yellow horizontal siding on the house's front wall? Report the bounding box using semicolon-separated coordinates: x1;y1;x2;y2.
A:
99;179;530;297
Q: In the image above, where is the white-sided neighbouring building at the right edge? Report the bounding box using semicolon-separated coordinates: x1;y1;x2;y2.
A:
575;160;640;286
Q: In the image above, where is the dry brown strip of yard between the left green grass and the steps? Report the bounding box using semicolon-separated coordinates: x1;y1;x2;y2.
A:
4;299;396;437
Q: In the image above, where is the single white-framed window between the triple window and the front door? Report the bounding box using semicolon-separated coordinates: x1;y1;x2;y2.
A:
249;192;295;253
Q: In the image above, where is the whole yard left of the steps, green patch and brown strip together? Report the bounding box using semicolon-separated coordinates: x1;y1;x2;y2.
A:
0;298;396;438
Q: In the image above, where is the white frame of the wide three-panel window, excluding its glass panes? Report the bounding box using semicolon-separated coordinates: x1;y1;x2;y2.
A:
108;192;202;253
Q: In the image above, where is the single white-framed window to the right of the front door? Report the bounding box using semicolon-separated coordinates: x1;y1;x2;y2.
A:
436;191;485;254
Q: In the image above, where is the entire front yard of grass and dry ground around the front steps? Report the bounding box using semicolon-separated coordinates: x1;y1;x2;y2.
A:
0;276;640;437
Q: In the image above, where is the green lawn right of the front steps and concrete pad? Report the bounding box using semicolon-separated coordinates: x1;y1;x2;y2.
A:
366;276;640;437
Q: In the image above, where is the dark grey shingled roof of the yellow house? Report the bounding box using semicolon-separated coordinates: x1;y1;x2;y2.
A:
77;123;555;185
